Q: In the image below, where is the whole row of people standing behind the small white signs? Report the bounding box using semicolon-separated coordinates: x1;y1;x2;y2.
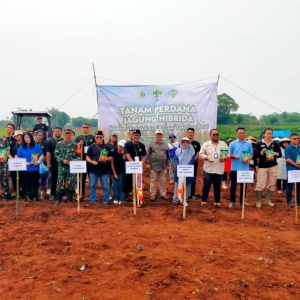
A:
0;118;300;208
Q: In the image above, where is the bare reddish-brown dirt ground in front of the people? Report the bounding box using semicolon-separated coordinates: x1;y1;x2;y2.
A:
0;162;300;300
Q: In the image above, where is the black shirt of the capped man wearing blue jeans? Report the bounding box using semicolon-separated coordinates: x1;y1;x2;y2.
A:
86;144;112;174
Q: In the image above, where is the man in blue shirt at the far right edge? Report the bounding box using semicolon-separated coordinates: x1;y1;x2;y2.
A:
285;133;300;207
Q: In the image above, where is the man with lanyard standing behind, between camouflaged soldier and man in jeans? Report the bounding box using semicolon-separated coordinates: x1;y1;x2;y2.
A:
75;123;95;200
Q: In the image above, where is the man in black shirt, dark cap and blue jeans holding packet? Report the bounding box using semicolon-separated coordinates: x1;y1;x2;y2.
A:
86;130;112;204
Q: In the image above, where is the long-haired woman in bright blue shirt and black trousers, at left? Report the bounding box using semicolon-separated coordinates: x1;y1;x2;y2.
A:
17;132;44;201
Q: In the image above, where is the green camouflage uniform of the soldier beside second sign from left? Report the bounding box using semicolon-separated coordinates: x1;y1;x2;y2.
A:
55;141;79;203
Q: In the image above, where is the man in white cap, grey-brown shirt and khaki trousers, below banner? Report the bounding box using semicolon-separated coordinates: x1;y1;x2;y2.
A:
146;129;170;201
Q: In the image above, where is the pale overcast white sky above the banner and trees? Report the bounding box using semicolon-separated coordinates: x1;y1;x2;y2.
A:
0;0;300;119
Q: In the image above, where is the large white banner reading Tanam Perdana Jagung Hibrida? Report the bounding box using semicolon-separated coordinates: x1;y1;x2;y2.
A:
97;82;218;144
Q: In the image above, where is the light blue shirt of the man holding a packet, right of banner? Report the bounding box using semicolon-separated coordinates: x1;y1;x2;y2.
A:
229;139;253;171
